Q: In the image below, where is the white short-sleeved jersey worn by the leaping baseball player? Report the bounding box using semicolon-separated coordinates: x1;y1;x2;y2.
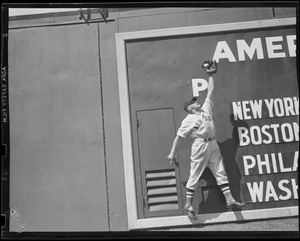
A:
177;98;215;139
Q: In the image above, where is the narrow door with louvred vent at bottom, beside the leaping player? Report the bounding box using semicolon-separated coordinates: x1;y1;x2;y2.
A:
136;108;182;217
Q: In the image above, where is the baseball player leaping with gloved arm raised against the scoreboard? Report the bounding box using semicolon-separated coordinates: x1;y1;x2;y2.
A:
167;60;245;220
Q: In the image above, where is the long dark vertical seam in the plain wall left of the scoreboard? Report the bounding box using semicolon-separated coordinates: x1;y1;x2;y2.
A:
97;23;110;231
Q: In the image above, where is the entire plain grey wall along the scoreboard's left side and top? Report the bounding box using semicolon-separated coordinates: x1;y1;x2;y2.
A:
9;8;296;231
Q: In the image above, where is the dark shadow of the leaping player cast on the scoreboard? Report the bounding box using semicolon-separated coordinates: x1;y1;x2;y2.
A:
199;114;249;213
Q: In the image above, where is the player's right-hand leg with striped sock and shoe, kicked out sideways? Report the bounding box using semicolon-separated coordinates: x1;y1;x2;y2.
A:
208;142;245;208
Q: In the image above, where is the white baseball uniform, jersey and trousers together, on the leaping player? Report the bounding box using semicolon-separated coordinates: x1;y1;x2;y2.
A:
177;99;228;190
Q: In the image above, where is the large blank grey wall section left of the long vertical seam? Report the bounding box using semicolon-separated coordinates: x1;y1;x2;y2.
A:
9;25;108;231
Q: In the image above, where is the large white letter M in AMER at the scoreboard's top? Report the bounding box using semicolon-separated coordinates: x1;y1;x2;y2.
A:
236;38;264;61
